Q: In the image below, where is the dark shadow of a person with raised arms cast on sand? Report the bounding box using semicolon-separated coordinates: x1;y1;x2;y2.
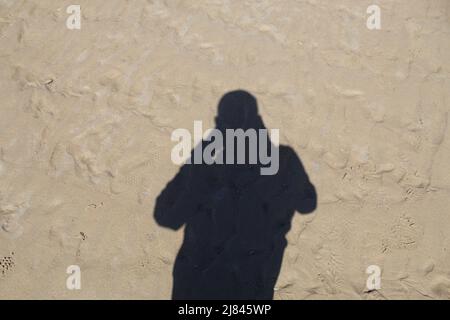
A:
154;90;317;299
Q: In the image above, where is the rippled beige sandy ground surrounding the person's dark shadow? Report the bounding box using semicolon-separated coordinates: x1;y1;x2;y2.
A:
0;0;450;299
